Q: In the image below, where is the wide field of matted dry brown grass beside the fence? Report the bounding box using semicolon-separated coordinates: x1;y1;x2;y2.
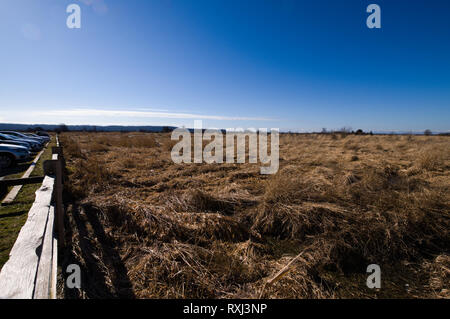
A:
60;132;450;298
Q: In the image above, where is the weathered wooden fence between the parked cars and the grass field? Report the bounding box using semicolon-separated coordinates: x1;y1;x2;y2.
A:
0;137;64;299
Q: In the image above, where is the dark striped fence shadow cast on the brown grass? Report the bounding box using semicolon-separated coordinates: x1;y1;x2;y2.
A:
62;205;135;299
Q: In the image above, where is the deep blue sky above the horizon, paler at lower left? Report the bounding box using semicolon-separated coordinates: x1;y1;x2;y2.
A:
0;0;450;131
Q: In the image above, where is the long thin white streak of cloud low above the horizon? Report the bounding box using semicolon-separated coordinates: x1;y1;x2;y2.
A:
36;109;274;121
